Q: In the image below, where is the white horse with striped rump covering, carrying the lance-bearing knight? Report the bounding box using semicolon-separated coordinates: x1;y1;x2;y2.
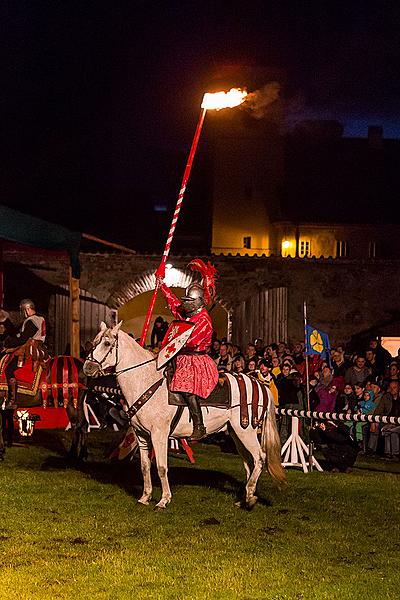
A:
83;321;285;509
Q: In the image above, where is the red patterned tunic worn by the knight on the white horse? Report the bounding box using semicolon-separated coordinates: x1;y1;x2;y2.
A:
161;283;218;398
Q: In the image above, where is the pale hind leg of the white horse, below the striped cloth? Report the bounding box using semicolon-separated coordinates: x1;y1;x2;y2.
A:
230;425;266;509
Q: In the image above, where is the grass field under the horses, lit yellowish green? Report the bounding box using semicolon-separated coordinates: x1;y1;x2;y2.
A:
0;430;400;600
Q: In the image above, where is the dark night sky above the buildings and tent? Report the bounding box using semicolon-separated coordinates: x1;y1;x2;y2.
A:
0;0;400;247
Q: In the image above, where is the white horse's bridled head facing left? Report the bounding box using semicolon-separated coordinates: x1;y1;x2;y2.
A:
83;321;122;377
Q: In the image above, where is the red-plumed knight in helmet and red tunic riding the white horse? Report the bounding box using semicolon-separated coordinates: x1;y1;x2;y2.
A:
156;259;218;440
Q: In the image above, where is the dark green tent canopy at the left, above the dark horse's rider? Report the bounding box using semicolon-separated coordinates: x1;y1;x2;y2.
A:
0;205;82;279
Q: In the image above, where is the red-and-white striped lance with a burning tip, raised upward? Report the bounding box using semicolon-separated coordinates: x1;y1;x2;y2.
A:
140;88;247;346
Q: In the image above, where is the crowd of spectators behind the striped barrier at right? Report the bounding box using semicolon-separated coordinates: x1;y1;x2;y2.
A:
206;338;400;460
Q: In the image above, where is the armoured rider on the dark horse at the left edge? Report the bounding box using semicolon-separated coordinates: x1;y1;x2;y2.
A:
4;298;46;406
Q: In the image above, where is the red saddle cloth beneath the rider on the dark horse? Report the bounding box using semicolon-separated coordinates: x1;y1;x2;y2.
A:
0;352;43;406
